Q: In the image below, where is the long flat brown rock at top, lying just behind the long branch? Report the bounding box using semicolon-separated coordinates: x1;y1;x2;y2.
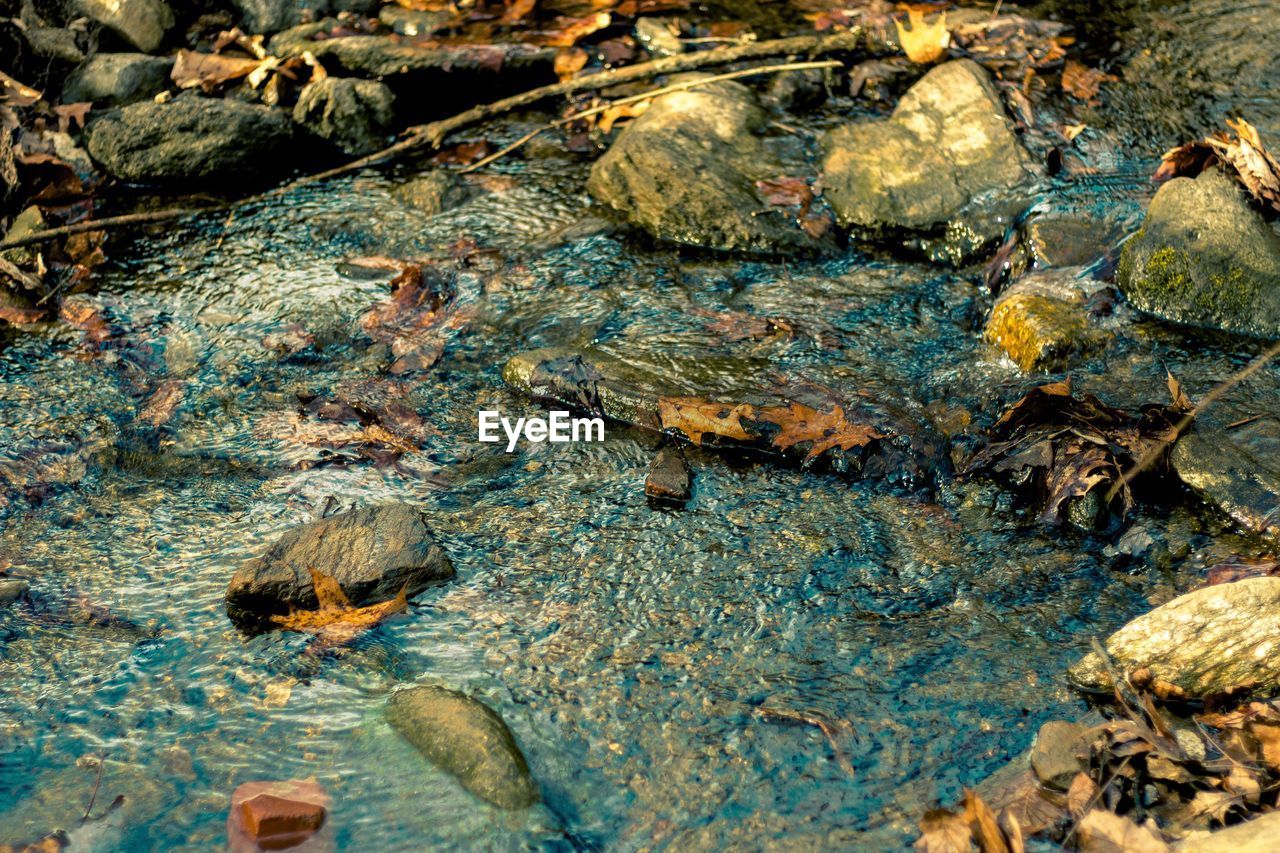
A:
270;18;556;86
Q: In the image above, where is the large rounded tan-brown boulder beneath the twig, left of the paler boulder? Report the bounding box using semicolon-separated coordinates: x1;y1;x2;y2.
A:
586;82;822;251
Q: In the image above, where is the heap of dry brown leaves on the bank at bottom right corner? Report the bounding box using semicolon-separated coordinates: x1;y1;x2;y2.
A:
915;680;1280;853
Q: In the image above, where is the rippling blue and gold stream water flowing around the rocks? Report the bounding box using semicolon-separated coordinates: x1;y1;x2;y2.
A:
0;3;1280;850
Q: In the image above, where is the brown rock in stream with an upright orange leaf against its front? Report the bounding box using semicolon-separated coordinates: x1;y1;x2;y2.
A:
227;503;453;629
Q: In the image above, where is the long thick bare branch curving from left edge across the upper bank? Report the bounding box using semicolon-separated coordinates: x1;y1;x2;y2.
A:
0;27;865;251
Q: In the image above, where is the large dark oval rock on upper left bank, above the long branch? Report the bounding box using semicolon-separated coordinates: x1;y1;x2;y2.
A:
88;97;297;183
